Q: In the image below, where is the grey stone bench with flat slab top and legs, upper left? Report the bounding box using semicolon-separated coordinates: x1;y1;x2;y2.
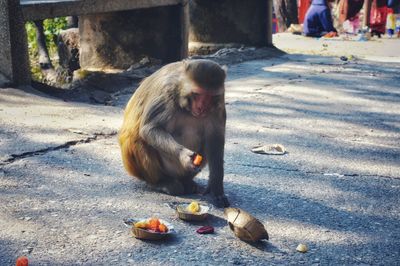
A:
0;0;189;85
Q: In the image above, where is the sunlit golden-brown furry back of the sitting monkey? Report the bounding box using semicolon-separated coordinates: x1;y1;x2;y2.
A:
119;62;183;183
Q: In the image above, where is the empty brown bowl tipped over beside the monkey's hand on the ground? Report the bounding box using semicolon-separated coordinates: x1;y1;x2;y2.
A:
224;208;269;242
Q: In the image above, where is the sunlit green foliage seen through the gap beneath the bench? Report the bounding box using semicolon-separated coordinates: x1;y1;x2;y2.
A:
25;17;67;81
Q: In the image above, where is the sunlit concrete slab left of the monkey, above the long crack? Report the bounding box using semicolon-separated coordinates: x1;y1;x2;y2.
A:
0;87;122;163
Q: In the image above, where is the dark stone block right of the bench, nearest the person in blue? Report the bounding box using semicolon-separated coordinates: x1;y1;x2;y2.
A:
189;0;272;47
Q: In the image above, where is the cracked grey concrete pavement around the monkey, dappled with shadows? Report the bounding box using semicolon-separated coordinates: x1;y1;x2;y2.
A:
0;36;400;265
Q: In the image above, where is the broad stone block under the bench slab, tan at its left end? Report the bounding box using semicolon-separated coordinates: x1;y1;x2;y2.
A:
79;2;188;70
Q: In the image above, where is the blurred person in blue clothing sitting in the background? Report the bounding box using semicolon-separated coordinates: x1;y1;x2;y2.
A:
303;0;338;37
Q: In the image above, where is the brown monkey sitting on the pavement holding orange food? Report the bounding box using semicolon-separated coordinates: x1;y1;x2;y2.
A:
119;59;229;207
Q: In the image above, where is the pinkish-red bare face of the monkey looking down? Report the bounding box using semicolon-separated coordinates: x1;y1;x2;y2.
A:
190;87;224;117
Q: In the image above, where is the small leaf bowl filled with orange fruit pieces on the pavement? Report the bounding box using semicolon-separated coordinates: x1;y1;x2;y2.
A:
124;218;174;240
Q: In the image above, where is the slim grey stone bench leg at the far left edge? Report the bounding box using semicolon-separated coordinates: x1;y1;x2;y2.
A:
0;0;31;85
